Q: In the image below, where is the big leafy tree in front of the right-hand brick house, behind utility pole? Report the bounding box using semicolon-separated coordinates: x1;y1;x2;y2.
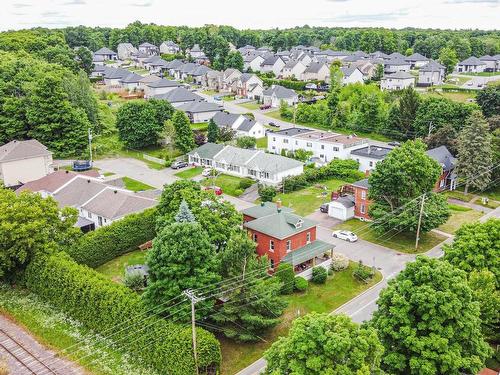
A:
368;141;449;232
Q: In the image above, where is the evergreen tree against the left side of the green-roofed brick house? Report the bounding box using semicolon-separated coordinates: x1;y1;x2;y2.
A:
212;231;286;341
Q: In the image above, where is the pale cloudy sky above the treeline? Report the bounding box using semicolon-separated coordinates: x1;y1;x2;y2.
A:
0;0;500;30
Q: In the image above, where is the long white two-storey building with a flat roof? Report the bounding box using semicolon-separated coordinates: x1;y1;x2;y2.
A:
267;128;368;163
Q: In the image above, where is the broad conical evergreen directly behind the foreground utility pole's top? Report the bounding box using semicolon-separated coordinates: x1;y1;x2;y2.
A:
143;221;220;321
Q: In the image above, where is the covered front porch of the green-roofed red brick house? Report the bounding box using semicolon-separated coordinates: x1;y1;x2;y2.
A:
282;240;335;280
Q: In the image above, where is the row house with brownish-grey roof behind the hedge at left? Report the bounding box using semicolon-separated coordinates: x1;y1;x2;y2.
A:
16;171;158;232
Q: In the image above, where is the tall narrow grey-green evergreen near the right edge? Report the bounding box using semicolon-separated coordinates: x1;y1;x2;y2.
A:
458;111;493;194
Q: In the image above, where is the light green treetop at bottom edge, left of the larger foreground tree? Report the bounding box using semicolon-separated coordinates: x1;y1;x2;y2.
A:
265;313;384;375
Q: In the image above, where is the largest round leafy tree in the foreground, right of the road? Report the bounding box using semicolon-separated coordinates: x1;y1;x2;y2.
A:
371;257;491;375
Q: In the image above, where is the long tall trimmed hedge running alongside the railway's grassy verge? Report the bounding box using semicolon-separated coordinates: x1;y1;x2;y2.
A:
24;252;221;375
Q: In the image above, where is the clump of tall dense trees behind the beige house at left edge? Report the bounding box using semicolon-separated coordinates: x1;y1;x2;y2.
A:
0;51;98;157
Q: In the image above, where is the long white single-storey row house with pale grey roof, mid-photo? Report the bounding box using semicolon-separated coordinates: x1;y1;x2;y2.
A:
188;143;304;185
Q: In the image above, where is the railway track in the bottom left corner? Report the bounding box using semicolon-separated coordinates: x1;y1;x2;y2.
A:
0;328;59;375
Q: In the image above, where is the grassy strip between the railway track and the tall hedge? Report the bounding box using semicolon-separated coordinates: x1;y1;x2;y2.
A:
0;284;156;375
